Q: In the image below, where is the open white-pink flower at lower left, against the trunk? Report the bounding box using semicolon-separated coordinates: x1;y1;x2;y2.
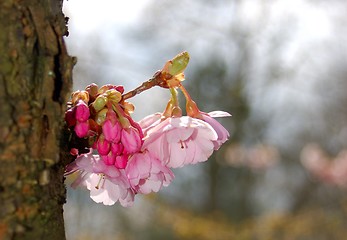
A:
66;152;135;207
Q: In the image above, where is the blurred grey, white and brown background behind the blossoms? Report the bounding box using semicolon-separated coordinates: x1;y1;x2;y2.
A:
64;0;347;240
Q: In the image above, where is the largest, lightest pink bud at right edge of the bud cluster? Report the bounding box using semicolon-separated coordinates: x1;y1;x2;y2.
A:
121;126;142;153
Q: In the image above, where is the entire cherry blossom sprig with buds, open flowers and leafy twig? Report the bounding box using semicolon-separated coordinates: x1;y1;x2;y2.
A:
65;52;230;207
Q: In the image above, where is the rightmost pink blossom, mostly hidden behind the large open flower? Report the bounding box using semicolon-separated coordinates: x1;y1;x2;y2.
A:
201;111;231;150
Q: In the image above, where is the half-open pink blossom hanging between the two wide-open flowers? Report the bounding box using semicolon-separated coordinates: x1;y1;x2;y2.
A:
125;151;174;194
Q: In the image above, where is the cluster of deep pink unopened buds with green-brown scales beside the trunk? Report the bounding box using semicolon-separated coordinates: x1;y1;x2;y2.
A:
65;84;143;169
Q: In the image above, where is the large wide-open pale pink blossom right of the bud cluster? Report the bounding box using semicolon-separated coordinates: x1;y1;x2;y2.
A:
140;115;218;168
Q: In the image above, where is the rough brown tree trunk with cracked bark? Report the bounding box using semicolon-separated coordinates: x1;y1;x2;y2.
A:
0;0;73;240
